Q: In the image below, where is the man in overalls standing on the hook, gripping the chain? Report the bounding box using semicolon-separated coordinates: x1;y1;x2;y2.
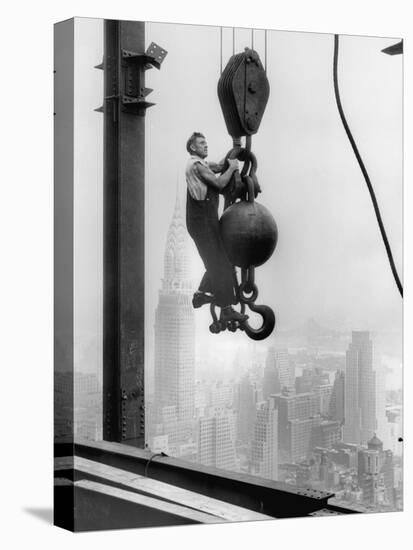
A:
185;132;248;322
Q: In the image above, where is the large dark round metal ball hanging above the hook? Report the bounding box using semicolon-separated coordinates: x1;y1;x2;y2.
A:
220;201;278;268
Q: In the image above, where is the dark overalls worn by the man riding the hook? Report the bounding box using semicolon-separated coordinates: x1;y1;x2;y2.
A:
186;185;235;307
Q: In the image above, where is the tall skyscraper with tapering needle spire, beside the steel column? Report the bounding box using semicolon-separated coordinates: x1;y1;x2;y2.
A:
154;198;195;434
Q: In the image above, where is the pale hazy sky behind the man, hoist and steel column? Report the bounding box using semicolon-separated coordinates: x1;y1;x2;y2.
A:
75;19;402;378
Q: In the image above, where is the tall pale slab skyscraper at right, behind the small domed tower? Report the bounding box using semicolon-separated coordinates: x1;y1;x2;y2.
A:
344;331;377;445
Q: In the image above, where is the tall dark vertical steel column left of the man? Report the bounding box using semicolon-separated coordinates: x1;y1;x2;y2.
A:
103;20;145;447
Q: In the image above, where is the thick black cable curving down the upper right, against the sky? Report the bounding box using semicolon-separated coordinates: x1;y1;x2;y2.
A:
333;34;403;297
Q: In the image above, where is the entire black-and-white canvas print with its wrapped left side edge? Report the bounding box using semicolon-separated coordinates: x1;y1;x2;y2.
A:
55;18;403;531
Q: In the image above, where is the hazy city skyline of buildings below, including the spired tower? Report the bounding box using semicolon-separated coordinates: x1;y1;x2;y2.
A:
141;199;402;511
